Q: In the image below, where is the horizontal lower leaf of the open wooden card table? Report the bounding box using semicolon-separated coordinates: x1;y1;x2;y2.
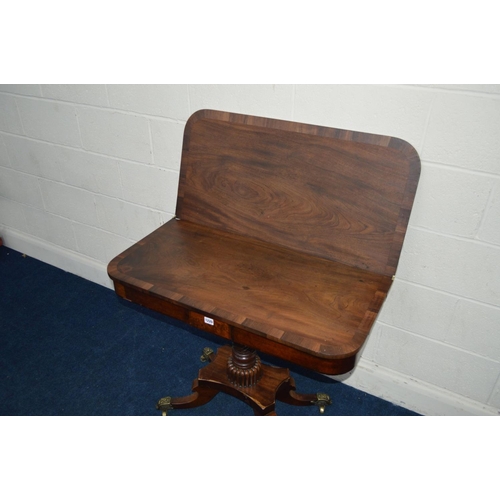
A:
109;219;392;358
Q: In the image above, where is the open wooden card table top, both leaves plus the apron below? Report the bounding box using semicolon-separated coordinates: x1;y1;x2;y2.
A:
108;110;420;411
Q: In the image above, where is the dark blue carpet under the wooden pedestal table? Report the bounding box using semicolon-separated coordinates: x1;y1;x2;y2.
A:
0;247;416;416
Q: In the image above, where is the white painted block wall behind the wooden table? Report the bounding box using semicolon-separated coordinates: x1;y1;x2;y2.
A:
0;85;500;415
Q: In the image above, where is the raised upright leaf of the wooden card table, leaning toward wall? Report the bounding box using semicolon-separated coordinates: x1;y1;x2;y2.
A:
177;111;419;276
